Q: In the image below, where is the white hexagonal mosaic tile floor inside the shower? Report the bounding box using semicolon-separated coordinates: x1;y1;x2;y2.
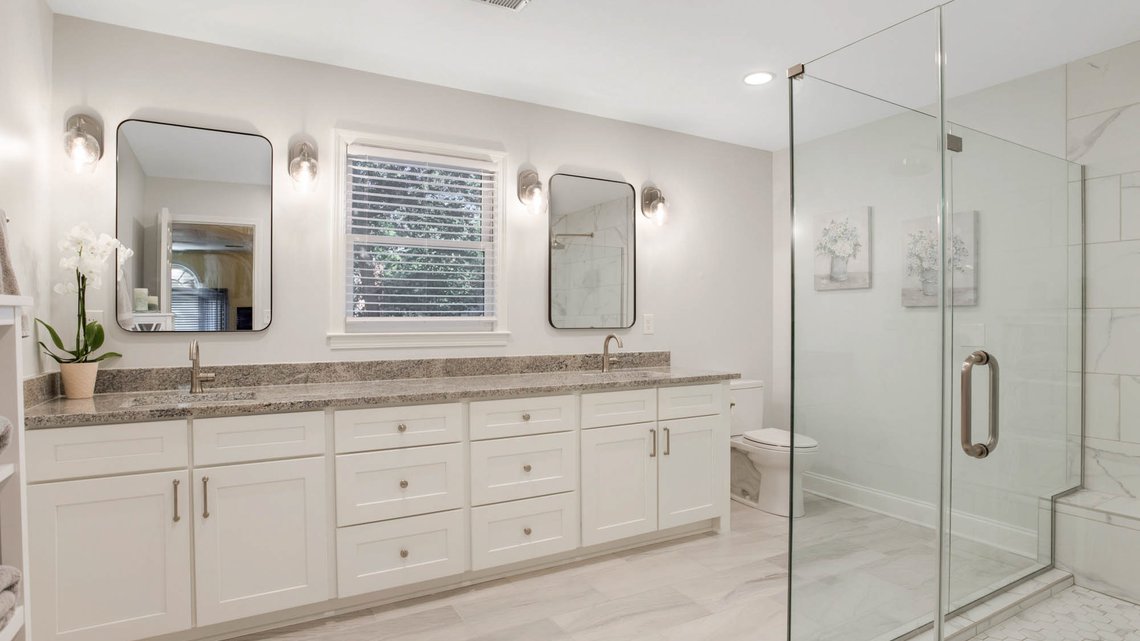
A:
974;587;1140;641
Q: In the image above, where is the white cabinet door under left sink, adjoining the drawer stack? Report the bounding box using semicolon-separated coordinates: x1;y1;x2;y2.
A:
194;459;329;625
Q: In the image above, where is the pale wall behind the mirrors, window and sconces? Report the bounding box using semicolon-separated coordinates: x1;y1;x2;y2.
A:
51;16;772;408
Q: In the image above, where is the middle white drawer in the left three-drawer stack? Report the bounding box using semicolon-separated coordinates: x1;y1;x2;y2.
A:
336;443;464;526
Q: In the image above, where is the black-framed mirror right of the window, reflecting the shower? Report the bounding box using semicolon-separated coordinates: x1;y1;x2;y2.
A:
549;173;636;330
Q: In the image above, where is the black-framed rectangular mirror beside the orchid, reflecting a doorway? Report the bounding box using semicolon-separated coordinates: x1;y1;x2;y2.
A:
116;120;272;332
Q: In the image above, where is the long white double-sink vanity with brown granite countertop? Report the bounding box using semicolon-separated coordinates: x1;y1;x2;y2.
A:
26;367;734;641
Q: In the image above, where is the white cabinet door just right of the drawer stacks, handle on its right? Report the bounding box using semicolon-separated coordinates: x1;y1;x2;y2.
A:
581;423;660;545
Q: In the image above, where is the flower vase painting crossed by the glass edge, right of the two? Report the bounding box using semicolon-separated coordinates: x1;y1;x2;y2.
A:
903;211;978;307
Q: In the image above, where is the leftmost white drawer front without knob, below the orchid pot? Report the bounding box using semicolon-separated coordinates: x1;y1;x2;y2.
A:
26;421;189;482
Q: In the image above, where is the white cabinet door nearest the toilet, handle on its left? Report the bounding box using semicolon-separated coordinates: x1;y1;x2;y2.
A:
658;416;731;529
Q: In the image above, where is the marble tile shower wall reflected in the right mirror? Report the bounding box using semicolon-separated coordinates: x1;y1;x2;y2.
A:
551;198;630;327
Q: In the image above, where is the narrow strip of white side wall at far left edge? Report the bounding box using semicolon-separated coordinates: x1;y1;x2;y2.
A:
0;0;53;374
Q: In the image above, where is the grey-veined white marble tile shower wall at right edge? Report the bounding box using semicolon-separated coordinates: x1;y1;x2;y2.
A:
1068;42;1140;498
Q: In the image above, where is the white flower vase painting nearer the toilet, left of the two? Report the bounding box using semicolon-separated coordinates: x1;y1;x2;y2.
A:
812;206;871;291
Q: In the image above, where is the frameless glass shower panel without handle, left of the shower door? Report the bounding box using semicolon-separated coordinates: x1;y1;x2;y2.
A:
790;11;943;641
